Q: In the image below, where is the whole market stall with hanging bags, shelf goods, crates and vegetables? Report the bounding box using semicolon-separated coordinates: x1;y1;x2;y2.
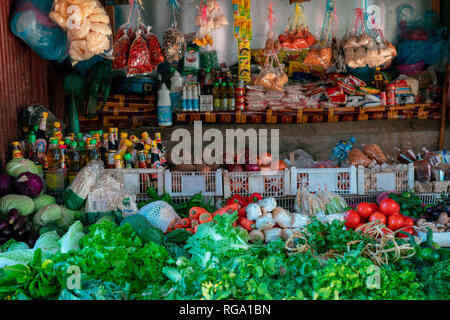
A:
0;0;450;300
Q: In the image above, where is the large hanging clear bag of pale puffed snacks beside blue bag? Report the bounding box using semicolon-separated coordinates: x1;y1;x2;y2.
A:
49;0;112;64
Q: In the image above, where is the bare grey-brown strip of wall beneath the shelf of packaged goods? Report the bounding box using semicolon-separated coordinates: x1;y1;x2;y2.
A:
146;120;450;160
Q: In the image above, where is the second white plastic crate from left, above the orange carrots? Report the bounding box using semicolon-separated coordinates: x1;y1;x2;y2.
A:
164;169;223;197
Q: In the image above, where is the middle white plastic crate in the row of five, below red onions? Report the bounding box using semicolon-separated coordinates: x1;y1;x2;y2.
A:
223;169;290;199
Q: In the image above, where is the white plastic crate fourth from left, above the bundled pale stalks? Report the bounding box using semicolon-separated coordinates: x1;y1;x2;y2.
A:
291;167;358;195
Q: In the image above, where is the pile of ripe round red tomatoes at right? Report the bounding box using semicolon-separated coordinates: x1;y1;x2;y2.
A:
345;199;414;238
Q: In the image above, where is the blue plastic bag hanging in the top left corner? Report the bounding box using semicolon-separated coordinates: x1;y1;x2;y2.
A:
10;0;67;61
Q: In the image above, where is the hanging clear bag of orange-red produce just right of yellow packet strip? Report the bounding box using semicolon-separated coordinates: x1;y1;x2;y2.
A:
278;3;316;50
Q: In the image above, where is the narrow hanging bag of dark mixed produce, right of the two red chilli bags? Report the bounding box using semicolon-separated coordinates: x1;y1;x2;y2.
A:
162;0;186;63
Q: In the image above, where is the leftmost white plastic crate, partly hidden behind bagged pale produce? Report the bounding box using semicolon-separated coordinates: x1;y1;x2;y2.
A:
105;169;164;202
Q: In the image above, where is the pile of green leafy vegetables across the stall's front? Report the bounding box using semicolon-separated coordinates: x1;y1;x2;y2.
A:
0;208;450;300
